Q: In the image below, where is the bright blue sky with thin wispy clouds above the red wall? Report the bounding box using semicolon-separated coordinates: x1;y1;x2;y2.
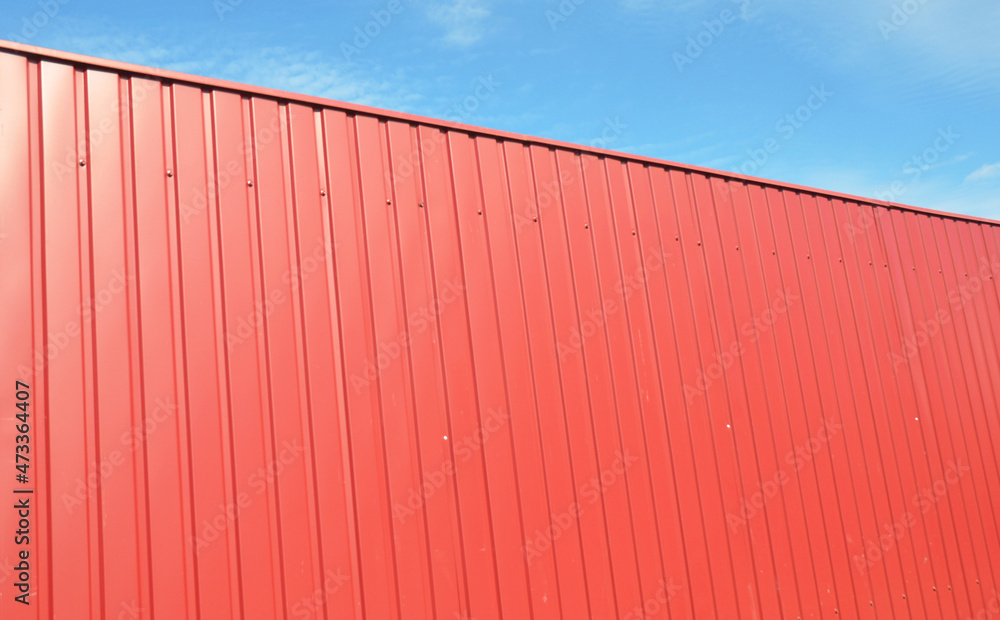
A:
0;0;1000;219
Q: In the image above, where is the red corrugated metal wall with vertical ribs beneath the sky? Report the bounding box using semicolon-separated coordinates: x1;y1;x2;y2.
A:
0;43;1000;620
